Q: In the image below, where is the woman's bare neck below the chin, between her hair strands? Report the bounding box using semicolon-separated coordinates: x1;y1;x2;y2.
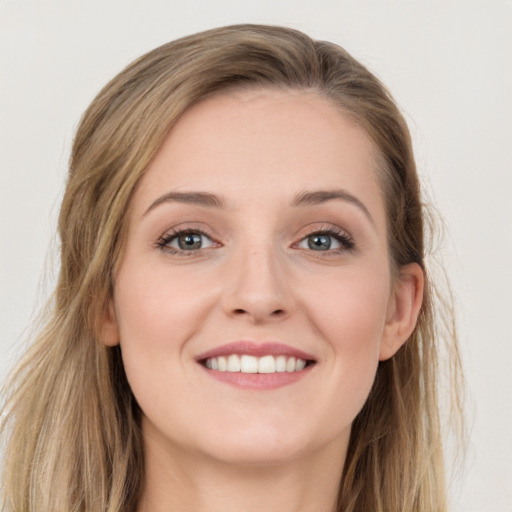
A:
137;422;346;512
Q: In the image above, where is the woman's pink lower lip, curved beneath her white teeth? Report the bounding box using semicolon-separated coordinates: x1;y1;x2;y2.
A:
201;365;313;391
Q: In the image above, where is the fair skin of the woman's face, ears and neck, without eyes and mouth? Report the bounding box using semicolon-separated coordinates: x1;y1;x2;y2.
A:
104;90;423;512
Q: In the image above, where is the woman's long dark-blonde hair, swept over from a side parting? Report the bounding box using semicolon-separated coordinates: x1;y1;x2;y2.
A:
2;25;460;512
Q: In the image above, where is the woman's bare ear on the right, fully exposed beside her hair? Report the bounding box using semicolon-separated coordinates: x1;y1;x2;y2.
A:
379;263;424;361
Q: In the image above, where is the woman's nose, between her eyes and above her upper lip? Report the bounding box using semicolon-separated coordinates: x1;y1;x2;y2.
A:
222;242;294;324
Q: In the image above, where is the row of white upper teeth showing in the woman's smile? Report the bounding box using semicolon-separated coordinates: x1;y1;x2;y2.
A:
205;354;306;373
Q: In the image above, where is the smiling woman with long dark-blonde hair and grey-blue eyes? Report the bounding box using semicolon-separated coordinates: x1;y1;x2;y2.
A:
3;25;464;512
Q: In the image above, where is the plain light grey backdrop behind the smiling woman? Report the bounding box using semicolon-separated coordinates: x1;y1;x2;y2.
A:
0;0;512;512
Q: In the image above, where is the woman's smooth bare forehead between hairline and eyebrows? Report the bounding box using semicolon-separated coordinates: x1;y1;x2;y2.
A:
132;89;380;220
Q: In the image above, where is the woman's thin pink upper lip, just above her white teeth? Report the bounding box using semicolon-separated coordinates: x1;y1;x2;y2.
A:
196;341;315;361
